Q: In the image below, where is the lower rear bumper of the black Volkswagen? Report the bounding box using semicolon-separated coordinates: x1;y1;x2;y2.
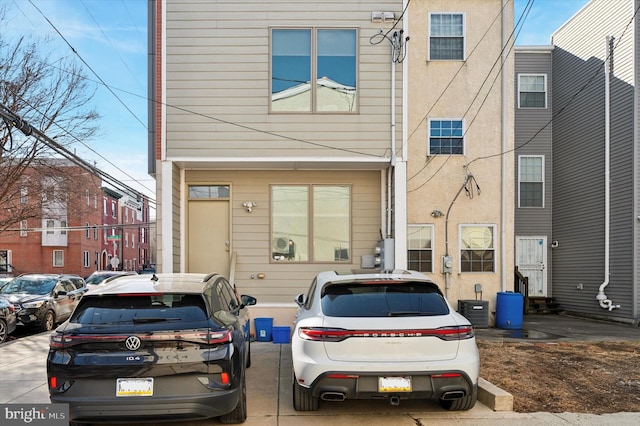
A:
51;389;240;424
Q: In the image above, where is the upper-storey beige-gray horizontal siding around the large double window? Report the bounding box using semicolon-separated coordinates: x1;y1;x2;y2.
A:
166;0;402;160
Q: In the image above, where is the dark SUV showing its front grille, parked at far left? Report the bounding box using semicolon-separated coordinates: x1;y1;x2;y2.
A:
0;274;85;331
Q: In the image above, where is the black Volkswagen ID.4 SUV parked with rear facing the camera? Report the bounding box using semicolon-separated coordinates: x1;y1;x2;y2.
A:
47;274;256;424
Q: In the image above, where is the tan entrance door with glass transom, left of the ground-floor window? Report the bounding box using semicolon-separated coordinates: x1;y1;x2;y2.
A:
186;185;230;276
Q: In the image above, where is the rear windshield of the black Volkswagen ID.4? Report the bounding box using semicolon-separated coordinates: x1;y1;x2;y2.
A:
70;293;207;325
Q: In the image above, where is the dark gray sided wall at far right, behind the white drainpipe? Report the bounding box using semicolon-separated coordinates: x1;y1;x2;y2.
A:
553;0;637;319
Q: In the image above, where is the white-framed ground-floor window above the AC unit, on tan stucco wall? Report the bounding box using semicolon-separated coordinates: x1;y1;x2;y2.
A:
460;225;496;272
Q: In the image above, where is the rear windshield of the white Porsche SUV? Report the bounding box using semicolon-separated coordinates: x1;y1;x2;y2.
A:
322;282;449;317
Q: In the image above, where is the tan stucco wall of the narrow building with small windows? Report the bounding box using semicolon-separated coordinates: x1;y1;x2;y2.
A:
406;0;515;304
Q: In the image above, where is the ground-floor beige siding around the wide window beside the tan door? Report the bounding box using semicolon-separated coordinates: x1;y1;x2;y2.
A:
185;170;381;303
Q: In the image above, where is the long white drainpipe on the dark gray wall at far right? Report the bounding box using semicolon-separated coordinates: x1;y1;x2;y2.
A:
596;36;620;312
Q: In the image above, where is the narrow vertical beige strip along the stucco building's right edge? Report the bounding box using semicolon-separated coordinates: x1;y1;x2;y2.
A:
500;0;513;292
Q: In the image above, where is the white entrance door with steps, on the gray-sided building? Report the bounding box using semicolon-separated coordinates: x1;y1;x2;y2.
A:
516;237;547;297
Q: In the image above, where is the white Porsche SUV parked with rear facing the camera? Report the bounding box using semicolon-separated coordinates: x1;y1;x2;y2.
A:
291;271;480;411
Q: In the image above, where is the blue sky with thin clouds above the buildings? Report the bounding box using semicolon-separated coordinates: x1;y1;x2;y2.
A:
0;0;592;206
